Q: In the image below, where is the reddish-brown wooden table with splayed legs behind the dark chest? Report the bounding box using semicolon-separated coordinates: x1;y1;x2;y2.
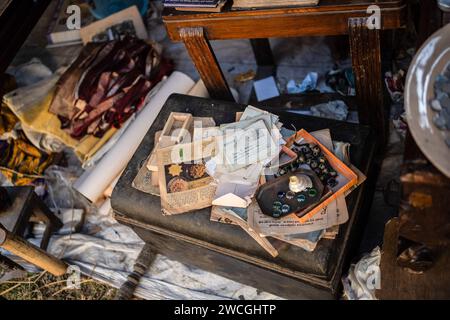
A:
163;0;406;144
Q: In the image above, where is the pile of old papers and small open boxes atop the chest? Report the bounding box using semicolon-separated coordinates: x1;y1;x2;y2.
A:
133;106;365;257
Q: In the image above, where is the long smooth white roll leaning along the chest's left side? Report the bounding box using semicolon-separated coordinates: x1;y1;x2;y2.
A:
74;71;194;202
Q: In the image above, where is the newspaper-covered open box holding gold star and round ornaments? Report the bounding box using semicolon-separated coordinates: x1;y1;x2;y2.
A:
157;139;216;215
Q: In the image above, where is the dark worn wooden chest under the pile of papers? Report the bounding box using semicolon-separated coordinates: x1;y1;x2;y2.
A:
112;94;375;299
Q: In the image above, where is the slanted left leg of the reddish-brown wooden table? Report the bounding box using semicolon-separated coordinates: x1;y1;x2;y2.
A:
179;27;234;101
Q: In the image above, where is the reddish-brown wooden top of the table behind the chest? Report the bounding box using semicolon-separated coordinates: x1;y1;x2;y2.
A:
163;1;406;41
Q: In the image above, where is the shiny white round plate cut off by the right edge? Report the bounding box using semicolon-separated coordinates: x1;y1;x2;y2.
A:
405;24;450;177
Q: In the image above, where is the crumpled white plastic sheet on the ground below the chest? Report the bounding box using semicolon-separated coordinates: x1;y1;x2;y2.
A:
35;200;279;300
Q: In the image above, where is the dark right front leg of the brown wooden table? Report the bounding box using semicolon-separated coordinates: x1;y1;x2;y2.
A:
349;18;387;145
